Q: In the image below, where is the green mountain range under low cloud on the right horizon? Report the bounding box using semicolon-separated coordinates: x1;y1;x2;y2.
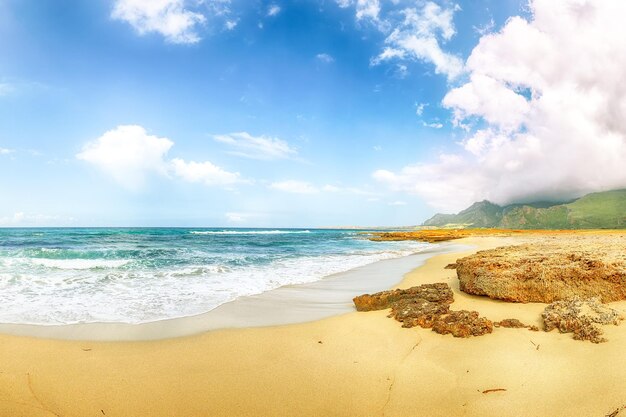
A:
422;190;626;229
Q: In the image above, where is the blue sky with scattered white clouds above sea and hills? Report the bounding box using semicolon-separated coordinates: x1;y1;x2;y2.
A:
0;0;626;227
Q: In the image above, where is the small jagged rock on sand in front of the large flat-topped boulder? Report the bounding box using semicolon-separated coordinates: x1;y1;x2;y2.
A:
541;297;624;343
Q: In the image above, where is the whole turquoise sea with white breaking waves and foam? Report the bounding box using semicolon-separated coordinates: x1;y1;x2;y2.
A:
0;228;430;325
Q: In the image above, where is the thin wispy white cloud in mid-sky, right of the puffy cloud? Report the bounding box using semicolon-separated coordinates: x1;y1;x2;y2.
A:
213;132;298;160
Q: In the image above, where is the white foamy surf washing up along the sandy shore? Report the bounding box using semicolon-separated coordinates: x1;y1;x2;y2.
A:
0;242;430;324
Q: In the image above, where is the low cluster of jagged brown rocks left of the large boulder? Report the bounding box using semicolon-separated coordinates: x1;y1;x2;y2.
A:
354;283;493;337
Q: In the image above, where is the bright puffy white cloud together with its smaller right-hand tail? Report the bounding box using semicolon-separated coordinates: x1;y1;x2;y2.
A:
76;125;246;190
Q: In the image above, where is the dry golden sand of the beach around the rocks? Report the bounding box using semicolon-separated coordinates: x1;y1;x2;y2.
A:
0;236;626;417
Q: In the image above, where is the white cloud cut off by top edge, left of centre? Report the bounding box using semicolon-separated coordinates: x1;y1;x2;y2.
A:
111;0;206;43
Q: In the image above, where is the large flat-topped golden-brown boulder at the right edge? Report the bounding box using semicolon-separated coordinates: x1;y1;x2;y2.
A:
456;237;626;303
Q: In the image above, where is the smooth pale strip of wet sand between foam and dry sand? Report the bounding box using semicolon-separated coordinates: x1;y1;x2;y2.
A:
0;242;468;342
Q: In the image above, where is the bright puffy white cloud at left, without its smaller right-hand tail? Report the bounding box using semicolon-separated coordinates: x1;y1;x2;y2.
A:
76;125;174;189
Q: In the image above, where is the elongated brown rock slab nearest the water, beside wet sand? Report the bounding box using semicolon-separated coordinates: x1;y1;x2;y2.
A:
352;282;454;311
